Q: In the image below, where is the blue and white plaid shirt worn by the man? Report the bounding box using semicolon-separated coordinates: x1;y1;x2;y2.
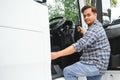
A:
73;20;111;74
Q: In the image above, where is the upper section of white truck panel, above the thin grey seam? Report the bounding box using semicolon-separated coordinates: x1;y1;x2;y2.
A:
0;0;49;31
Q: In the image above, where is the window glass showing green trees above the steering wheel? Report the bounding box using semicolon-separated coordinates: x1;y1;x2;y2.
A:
48;0;79;24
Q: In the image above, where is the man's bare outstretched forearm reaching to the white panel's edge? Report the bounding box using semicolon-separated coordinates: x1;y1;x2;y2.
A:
51;45;76;60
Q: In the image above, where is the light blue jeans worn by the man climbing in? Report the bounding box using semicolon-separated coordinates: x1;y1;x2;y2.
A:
63;62;102;80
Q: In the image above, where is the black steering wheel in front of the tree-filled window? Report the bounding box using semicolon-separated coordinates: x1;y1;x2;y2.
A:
49;17;66;31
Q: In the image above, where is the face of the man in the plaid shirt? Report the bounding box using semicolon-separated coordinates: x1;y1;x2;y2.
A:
83;8;97;25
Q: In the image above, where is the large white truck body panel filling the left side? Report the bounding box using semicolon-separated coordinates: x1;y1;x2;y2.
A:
0;0;51;80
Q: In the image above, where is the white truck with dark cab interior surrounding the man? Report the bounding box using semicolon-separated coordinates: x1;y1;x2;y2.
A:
0;0;120;80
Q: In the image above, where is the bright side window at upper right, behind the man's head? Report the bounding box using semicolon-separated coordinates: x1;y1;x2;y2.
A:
102;0;120;25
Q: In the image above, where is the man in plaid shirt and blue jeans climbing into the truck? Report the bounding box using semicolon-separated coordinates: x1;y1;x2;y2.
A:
51;6;110;80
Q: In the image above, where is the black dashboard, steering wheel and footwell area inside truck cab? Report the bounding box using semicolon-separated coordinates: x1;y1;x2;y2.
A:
50;17;80;79
